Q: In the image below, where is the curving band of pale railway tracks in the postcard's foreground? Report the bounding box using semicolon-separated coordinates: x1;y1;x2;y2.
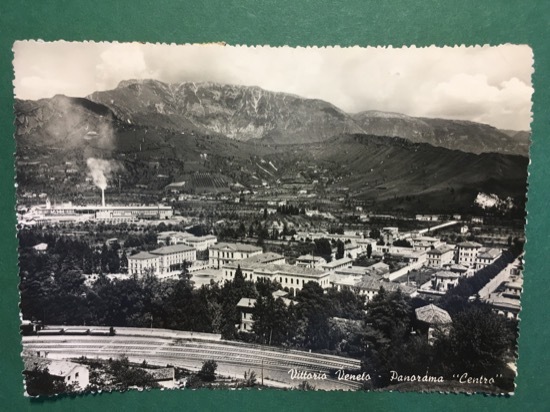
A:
23;334;360;389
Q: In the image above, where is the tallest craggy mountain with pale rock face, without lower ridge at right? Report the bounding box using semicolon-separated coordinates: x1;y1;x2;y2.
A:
89;80;361;143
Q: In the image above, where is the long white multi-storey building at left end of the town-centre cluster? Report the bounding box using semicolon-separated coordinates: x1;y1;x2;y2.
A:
128;245;197;275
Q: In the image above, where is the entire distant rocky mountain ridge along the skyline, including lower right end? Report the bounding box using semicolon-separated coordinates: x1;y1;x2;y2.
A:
83;79;529;156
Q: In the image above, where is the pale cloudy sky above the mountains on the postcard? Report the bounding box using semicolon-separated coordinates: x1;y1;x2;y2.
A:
13;41;533;130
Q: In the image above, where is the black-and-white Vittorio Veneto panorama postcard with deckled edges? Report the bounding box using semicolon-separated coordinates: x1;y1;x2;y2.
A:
13;41;533;396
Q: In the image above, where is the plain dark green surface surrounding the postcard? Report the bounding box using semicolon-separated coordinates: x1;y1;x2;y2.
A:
0;0;550;412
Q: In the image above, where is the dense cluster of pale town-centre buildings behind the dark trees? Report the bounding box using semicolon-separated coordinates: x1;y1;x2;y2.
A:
98;219;519;328
